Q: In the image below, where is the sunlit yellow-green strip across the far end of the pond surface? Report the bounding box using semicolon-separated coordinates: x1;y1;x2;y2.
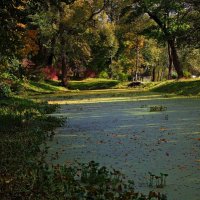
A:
48;89;186;105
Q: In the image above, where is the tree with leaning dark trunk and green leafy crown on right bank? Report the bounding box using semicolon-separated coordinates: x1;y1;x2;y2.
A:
121;0;199;78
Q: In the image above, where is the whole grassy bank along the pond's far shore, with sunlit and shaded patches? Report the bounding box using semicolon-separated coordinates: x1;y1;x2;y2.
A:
24;78;200;96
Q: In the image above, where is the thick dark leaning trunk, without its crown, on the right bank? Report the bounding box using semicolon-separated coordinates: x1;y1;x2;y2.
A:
168;39;183;78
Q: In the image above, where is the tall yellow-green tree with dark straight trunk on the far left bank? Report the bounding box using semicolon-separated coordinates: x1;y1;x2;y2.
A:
31;0;111;86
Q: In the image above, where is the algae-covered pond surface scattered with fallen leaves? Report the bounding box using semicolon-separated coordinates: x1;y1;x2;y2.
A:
49;91;200;200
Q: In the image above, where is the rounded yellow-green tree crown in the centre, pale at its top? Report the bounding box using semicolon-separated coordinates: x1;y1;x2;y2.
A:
87;11;118;76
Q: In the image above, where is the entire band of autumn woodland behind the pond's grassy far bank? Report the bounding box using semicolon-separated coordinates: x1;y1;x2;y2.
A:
0;0;200;91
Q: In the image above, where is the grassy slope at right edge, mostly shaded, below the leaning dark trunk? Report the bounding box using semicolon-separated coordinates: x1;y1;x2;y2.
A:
150;79;200;96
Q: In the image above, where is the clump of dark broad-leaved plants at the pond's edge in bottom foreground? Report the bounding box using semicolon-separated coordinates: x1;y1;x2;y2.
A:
28;161;138;200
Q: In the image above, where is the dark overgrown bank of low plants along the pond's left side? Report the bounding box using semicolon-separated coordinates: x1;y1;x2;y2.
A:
0;97;61;200
